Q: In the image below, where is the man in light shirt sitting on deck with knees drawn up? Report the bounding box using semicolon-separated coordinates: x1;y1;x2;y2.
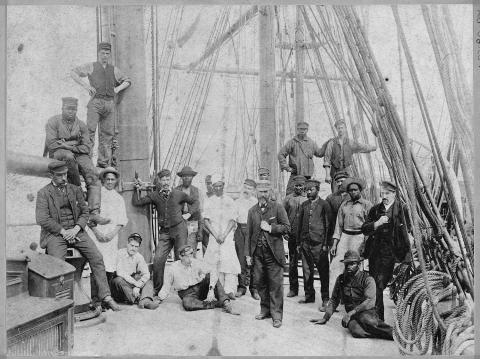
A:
112;233;158;309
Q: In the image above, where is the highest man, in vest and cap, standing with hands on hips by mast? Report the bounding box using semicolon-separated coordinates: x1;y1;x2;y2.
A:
70;42;132;168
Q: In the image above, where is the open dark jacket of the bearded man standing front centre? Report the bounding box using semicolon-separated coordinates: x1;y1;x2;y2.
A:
245;200;290;266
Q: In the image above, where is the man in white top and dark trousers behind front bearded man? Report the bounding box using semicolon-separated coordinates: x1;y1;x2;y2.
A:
233;178;260;300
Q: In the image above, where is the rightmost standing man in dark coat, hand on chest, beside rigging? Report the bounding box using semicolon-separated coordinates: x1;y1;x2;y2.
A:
362;181;411;320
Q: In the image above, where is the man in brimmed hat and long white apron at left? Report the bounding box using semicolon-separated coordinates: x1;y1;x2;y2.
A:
87;167;128;302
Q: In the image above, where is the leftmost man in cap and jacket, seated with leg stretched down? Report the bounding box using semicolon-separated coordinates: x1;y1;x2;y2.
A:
35;160;120;311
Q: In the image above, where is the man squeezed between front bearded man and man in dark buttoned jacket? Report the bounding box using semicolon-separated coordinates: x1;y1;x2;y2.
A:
283;175;307;297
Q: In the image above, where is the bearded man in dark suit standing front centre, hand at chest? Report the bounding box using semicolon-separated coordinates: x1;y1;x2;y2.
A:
245;180;290;328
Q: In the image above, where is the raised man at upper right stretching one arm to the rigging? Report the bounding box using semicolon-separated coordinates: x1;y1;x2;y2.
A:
323;119;377;192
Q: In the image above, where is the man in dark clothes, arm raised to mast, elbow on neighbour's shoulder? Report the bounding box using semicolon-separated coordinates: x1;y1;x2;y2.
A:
132;169;198;293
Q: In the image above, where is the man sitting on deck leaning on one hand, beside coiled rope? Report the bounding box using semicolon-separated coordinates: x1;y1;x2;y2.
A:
311;250;393;340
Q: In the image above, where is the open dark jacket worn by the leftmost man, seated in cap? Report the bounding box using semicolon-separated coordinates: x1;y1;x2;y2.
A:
35;183;88;248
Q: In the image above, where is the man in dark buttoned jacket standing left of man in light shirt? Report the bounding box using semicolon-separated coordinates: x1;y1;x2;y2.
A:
297;180;333;311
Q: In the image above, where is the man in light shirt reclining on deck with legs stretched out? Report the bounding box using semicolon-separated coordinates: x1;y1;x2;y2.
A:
158;245;240;315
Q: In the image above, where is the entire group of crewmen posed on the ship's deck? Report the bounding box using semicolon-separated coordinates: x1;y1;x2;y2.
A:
36;43;410;339
